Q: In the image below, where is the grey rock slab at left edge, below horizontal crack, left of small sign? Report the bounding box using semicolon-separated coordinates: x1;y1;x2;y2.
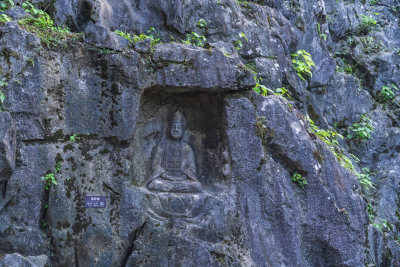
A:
0;144;48;255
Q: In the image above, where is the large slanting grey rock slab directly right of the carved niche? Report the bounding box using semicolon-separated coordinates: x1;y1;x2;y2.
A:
227;97;365;266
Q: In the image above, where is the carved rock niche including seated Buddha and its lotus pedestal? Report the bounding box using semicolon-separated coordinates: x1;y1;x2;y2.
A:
132;90;230;218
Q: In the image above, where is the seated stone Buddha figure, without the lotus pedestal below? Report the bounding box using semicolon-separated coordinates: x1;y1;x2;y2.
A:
147;111;201;193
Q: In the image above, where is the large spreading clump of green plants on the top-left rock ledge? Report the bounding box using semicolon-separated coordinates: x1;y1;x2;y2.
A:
18;2;81;48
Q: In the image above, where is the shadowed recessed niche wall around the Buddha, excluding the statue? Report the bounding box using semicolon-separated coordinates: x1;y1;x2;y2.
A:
132;89;230;189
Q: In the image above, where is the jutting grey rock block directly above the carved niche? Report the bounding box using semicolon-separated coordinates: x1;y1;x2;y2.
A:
153;43;254;92
